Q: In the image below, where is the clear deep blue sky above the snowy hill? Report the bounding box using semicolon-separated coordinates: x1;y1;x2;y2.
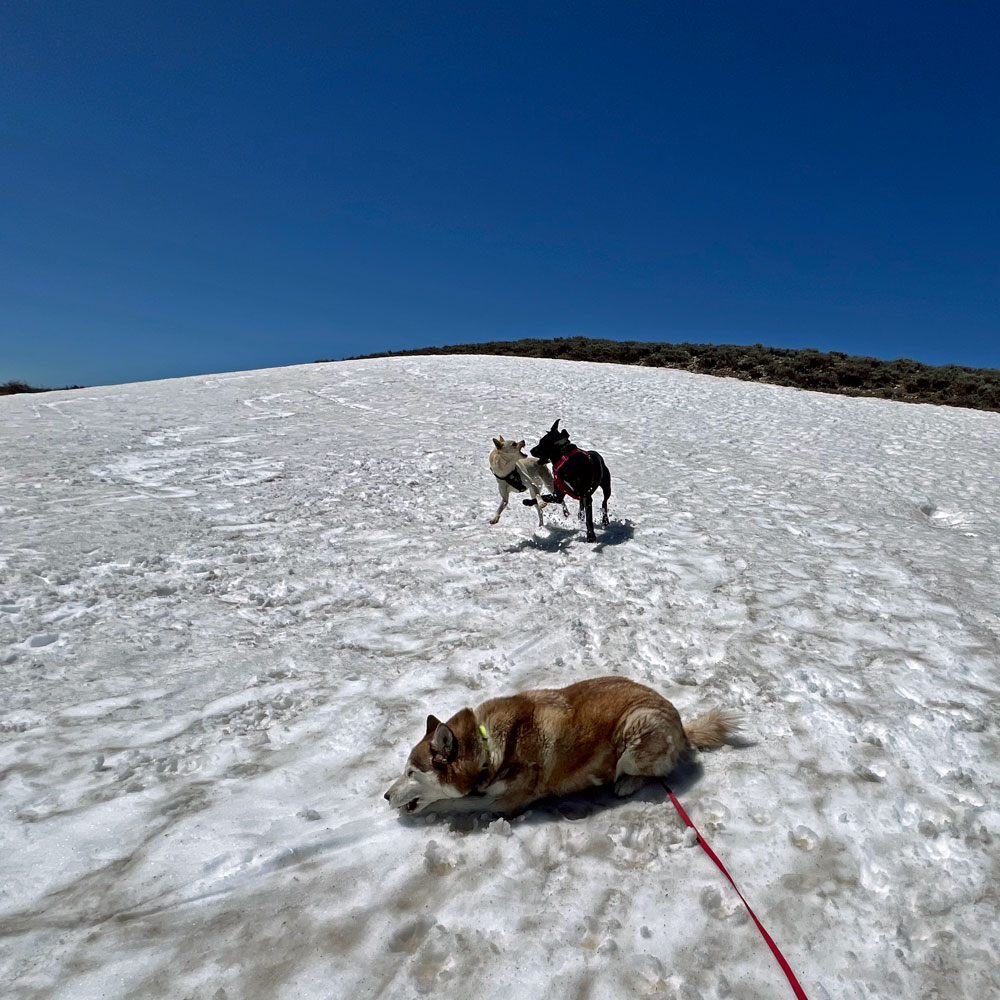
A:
0;0;1000;385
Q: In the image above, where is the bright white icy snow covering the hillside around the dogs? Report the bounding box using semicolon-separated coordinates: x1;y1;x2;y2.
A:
0;357;1000;1000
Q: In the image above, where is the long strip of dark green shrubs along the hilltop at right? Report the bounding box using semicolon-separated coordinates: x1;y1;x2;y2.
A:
338;337;1000;412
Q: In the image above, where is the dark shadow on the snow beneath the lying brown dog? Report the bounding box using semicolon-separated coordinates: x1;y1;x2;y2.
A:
390;756;728;833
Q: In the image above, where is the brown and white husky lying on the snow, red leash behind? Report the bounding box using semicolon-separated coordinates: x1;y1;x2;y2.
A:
385;677;738;815
